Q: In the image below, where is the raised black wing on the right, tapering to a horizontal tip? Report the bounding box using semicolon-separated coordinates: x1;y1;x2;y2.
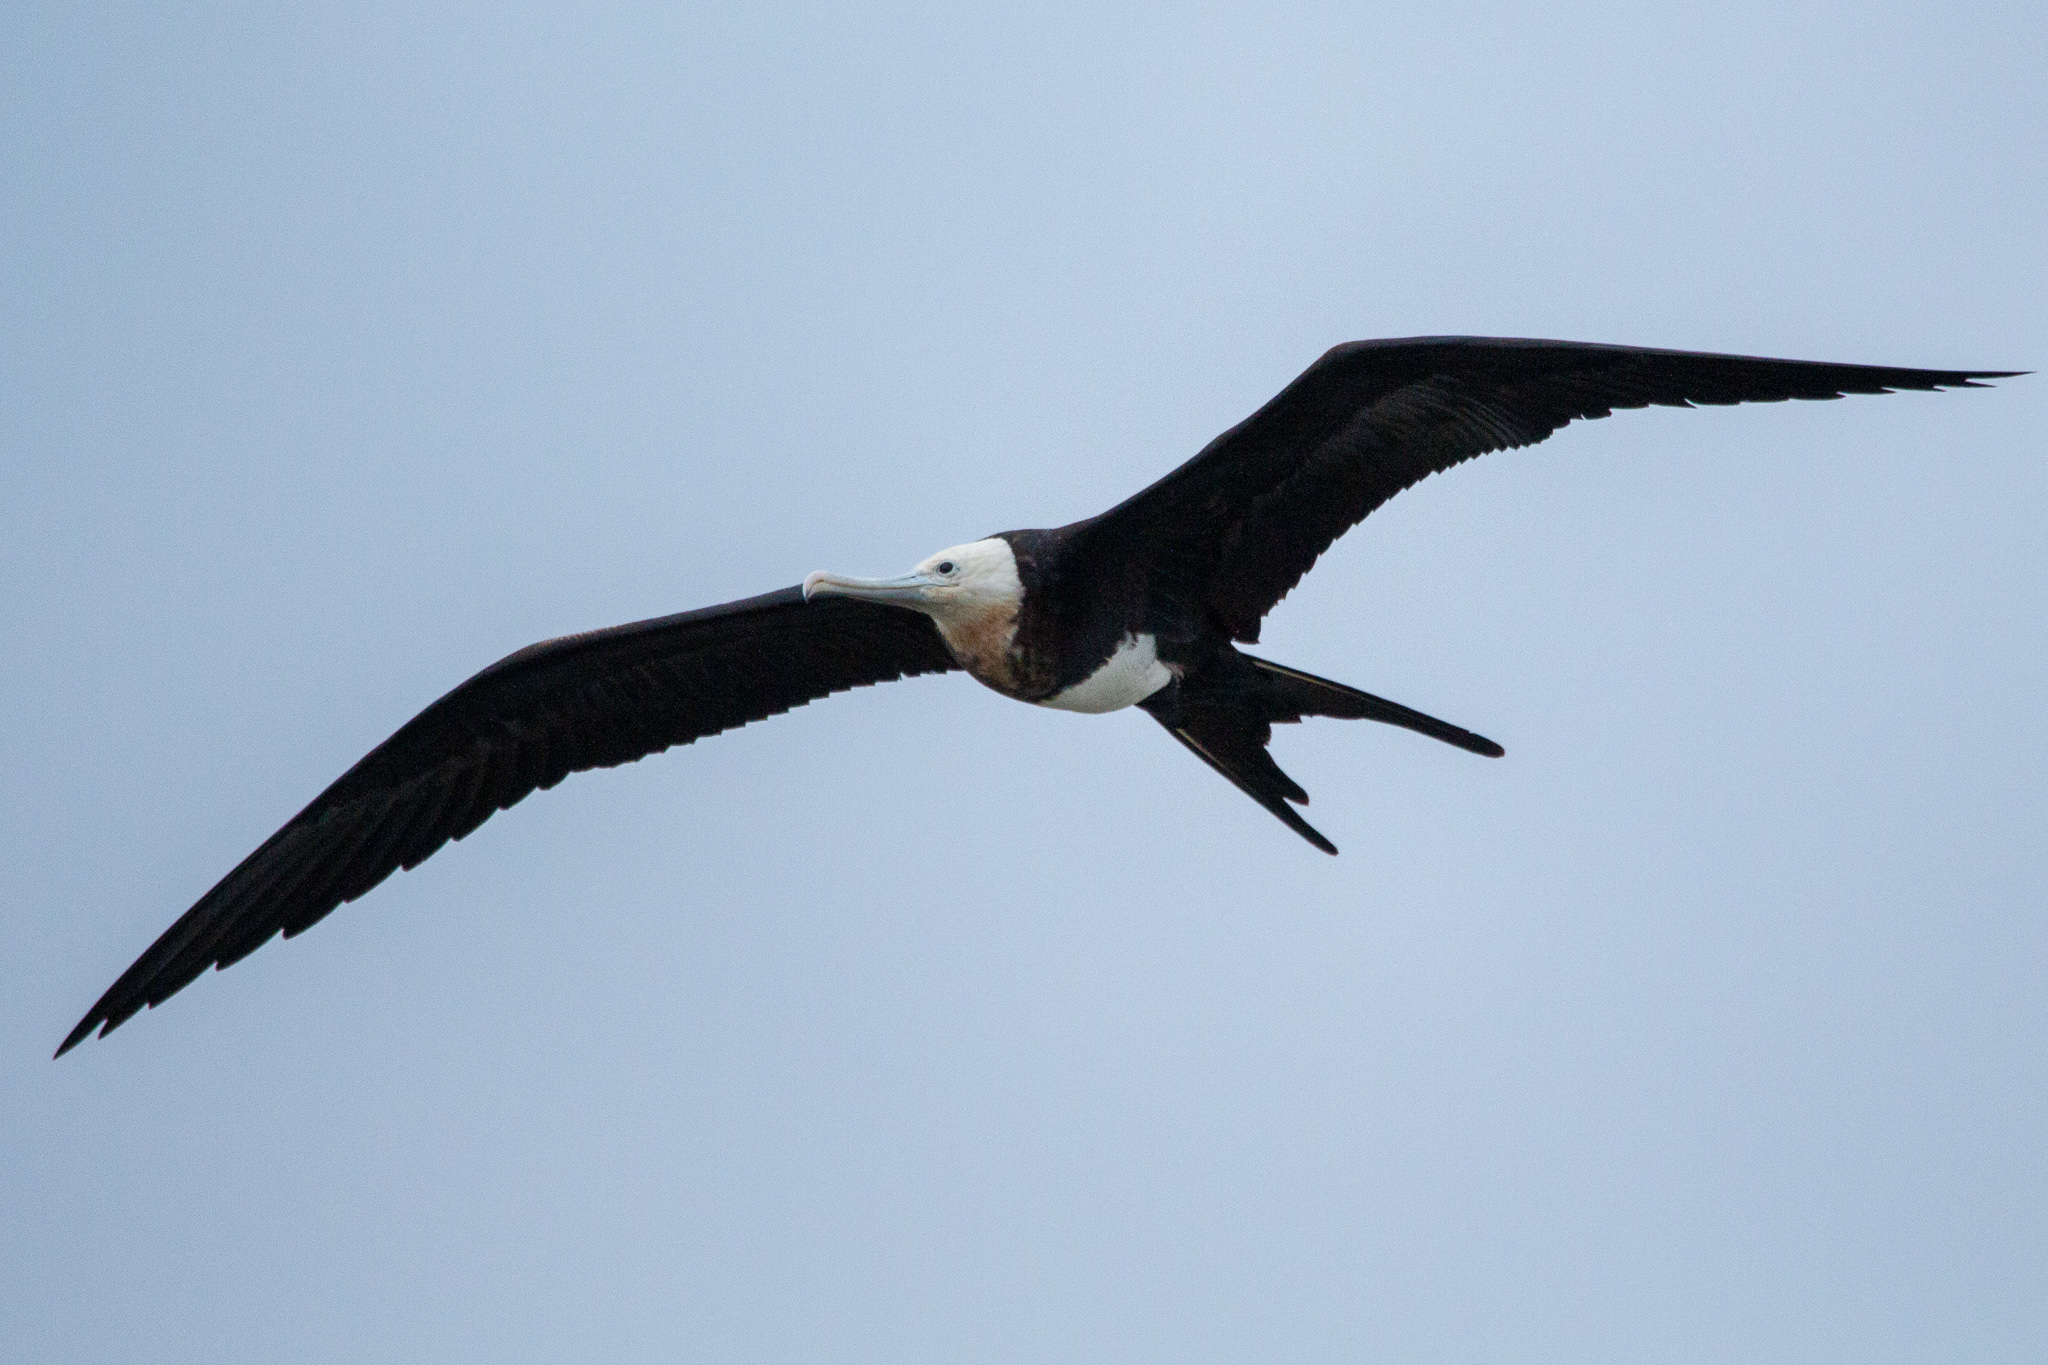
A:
1075;338;2009;643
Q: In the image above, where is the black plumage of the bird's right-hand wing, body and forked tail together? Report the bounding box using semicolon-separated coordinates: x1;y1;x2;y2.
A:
995;338;2011;853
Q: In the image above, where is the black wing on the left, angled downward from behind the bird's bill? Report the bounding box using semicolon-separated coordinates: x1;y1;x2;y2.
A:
57;587;958;1056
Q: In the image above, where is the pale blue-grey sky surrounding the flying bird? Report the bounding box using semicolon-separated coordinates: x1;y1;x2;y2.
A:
0;0;2048;1363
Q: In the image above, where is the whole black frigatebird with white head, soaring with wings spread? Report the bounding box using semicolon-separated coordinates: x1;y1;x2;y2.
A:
57;338;2019;1056
